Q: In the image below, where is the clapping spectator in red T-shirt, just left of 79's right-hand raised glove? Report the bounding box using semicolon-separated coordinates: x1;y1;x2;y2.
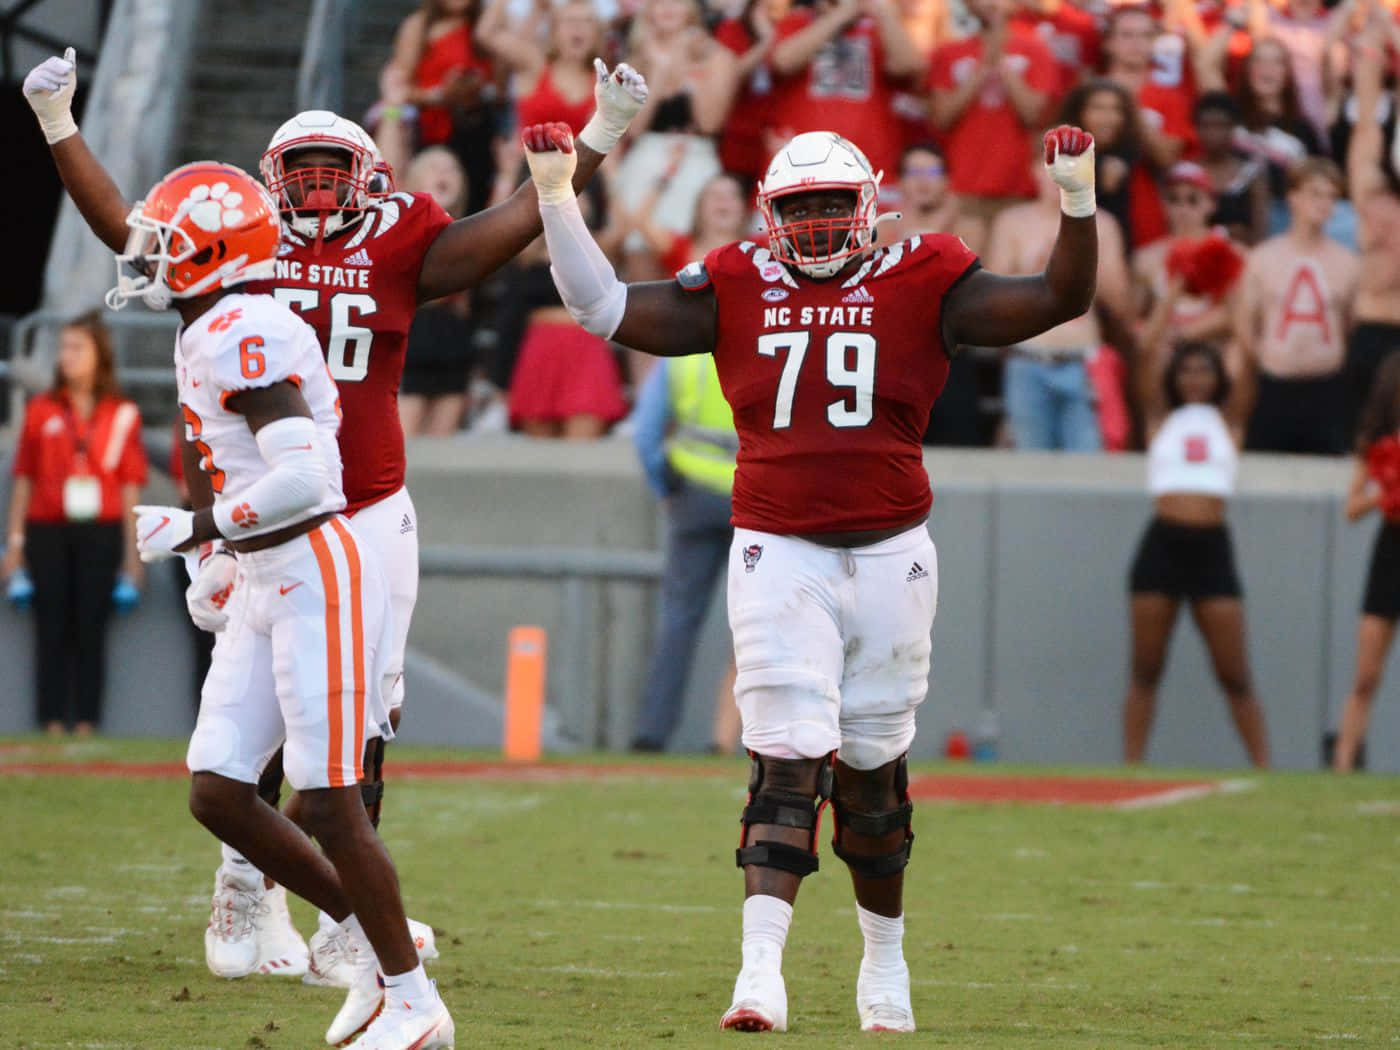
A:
928;0;1060;224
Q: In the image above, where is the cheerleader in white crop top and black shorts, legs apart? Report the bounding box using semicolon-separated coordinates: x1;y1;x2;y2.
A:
1123;343;1268;767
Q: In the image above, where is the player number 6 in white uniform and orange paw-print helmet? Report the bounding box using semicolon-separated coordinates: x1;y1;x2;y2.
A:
116;161;454;1050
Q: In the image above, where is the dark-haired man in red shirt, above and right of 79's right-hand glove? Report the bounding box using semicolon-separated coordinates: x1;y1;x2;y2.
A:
1103;7;1193;245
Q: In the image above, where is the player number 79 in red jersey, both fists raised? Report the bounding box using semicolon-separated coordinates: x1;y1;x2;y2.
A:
524;125;1098;1032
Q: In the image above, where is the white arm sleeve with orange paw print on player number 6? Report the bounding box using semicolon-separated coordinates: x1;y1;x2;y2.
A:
214;416;330;539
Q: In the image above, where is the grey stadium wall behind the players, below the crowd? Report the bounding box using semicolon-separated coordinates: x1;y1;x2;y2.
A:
0;438;1400;771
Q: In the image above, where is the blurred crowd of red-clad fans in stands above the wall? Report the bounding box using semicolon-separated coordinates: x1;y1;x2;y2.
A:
365;0;1400;454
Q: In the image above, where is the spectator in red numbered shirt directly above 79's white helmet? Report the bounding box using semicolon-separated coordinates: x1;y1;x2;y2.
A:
767;0;924;176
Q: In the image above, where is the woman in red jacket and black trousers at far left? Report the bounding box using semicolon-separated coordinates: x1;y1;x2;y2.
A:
0;315;146;735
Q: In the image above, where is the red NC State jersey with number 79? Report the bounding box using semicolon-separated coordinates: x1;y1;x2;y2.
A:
678;234;977;535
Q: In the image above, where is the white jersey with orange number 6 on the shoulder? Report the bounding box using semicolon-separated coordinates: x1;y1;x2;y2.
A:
175;294;346;539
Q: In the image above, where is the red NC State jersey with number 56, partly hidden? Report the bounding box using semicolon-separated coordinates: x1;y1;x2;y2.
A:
246;193;452;511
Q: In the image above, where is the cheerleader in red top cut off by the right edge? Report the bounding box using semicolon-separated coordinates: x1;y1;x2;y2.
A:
1331;354;1400;771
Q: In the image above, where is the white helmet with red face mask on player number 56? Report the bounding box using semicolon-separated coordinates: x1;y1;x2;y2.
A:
258;109;379;239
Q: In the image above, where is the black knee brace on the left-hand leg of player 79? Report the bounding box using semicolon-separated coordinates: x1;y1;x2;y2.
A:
734;752;832;876
